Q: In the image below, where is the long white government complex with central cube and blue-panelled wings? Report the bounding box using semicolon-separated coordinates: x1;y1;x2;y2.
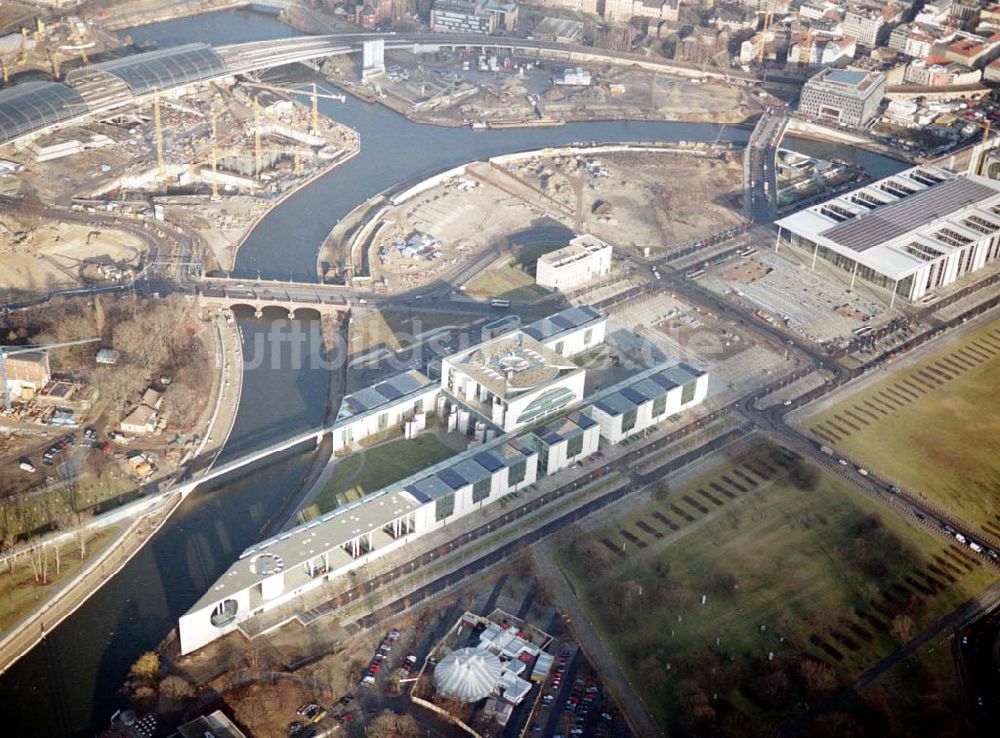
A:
178;307;708;653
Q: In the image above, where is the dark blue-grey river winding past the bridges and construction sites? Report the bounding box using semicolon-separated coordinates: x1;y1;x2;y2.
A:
0;11;903;738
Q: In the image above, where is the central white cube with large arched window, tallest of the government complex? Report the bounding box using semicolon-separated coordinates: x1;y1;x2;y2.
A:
441;331;584;432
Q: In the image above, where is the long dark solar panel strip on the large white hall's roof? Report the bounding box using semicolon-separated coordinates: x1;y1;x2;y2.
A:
821;178;997;251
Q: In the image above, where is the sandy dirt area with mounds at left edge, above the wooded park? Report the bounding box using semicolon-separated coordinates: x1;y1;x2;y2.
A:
0;216;144;300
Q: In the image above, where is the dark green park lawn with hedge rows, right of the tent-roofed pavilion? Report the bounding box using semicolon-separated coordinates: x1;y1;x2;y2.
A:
559;444;994;735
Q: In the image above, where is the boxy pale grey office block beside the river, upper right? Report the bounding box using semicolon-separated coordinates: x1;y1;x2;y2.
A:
799;69;886;128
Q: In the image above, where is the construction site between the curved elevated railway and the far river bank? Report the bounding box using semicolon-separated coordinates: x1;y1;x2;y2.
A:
330;51;766;128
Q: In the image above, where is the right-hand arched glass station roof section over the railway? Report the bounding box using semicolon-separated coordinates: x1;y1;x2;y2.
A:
86;44;226;95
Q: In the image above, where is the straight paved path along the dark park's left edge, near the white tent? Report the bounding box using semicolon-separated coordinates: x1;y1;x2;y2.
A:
531;541;660;738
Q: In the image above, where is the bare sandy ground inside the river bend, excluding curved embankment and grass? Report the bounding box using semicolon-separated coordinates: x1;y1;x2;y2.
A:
367;149;742;289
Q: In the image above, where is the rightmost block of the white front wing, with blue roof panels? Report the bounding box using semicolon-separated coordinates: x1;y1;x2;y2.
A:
591;363;708;444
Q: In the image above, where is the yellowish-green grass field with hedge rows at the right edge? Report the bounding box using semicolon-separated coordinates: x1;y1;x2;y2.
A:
805;321;1000;537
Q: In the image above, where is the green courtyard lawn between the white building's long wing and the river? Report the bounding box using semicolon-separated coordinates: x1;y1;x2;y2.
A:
303;432;459;520
